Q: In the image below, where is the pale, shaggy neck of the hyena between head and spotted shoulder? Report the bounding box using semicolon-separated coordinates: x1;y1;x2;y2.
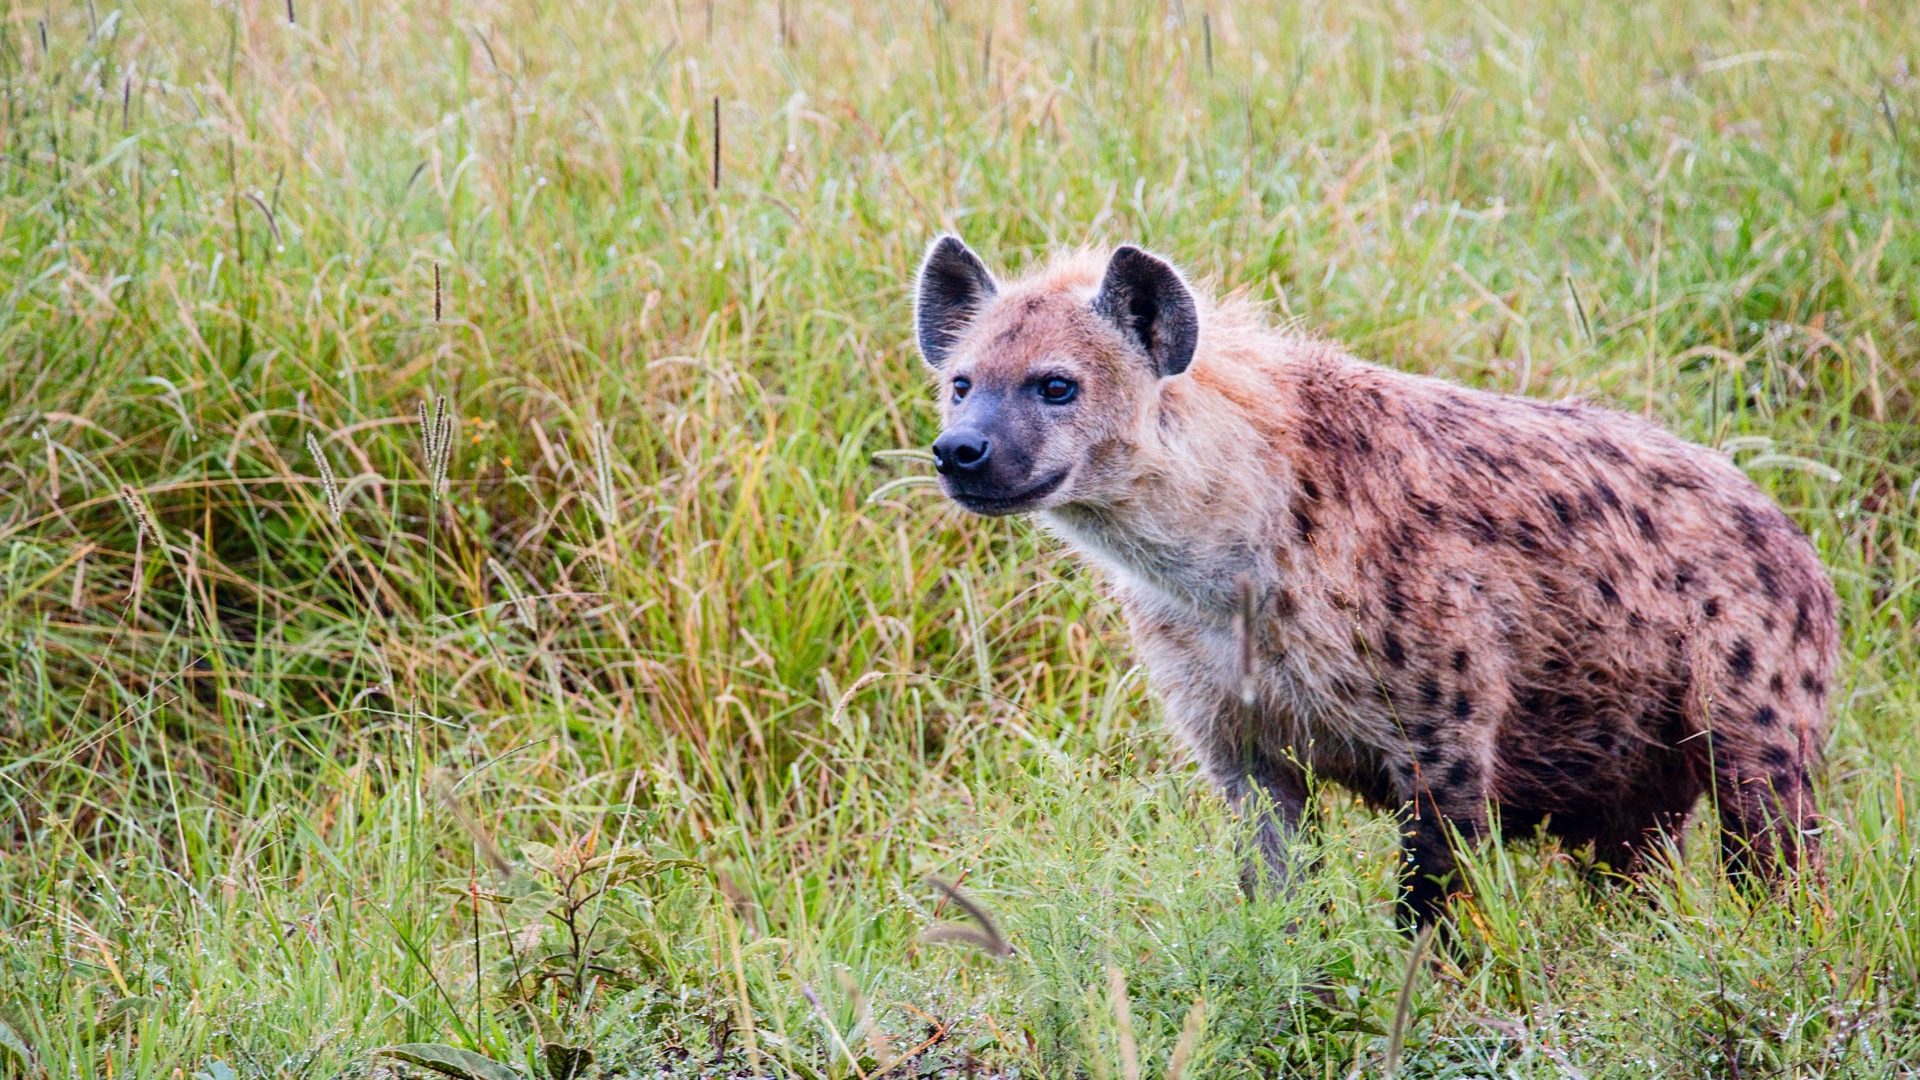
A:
1041;372;1292;625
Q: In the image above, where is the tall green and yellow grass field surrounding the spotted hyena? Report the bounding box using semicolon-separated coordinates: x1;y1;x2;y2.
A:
0;0;1920;1080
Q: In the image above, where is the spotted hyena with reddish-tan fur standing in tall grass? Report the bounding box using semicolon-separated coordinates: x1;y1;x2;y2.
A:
916;236;1837;922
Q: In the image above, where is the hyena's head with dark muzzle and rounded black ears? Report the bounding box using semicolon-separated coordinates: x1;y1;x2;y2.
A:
914;236;1200;515
